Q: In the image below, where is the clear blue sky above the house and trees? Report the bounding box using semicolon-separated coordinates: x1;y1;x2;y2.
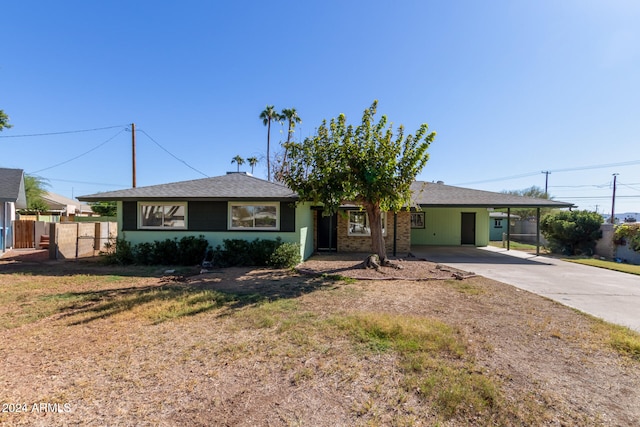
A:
0;0;640;213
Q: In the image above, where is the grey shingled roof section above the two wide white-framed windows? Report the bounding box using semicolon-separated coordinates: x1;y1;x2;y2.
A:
78;173;298;202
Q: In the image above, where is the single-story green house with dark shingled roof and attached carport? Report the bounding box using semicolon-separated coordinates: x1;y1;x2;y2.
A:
78;172;572;259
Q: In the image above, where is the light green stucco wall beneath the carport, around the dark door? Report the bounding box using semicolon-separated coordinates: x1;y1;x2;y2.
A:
411;208;489;246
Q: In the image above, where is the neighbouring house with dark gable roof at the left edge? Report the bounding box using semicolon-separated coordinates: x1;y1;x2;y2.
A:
0;168;27;252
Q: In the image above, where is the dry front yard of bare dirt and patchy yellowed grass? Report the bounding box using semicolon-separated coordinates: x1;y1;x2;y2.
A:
0;249;640;426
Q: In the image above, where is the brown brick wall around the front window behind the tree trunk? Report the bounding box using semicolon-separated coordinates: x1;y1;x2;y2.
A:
338;211;411;256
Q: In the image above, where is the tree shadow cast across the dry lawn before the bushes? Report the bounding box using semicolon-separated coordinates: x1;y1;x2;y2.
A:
50;268;336;325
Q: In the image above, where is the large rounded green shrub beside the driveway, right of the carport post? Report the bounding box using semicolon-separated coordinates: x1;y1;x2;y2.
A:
540;210;603;255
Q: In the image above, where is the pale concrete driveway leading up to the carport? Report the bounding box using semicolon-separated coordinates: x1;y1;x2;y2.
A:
411;246;640;332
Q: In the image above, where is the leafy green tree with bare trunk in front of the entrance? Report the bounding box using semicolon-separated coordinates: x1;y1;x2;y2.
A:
283;101;436;264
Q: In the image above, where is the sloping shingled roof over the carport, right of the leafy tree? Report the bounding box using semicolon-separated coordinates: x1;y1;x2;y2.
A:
411;181;574;208
